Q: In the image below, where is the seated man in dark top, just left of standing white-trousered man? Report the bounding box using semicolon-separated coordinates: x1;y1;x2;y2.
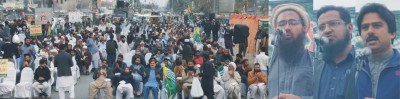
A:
32;59;51;98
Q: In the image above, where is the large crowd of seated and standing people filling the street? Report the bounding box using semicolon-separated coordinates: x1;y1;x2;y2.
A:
0;13;268;99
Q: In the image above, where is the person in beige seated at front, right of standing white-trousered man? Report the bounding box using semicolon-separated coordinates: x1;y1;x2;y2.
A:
89;60;114;99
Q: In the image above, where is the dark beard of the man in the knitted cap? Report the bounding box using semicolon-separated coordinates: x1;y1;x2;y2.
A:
279;33;306;60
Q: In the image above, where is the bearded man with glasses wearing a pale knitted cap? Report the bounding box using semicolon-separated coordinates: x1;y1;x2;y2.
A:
270;3;313;99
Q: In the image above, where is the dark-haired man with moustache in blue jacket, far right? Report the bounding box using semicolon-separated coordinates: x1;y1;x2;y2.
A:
356;3;400;99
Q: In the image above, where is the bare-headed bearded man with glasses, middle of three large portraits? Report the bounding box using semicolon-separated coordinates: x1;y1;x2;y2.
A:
314;6;356;99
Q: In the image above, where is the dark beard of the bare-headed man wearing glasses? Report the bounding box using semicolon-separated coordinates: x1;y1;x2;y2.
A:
322;31;351;61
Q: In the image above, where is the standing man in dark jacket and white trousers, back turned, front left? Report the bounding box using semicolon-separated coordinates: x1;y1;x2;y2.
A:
54;44;75;99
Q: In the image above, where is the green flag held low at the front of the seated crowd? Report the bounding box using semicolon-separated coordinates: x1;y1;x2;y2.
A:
163;65;178;99
